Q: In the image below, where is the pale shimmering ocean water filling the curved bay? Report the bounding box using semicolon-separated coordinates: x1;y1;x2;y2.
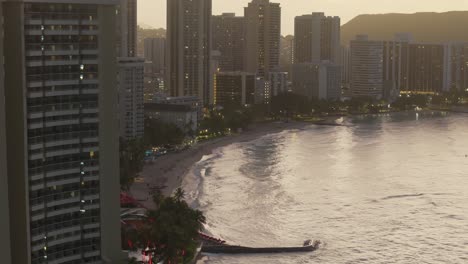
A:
184;111;468;264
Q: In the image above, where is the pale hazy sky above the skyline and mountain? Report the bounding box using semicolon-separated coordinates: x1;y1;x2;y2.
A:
138;0;468;35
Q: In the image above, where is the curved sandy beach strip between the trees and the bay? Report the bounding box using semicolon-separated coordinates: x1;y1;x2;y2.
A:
130;122;310;208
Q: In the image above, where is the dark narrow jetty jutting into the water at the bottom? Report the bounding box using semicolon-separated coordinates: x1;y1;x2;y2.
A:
201;240;321;254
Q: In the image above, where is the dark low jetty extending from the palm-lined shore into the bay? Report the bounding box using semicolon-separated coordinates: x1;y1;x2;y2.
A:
200;234;320;254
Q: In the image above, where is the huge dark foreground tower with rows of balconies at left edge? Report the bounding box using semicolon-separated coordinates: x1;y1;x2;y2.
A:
0;0;122;264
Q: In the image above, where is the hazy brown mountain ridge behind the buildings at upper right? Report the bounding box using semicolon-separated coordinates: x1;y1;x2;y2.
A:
341;11;468;45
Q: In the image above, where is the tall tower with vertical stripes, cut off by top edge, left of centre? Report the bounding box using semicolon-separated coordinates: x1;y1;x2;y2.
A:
166;0;211;104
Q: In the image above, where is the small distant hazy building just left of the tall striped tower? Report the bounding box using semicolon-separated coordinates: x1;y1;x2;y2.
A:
144;38;166;77
